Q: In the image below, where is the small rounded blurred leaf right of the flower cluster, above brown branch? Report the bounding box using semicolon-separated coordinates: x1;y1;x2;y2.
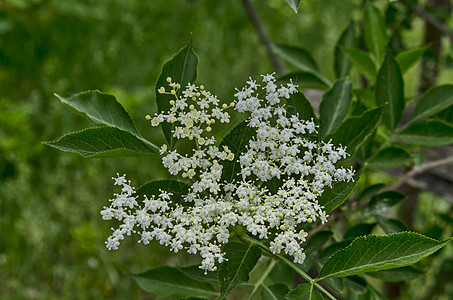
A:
368;147;412;170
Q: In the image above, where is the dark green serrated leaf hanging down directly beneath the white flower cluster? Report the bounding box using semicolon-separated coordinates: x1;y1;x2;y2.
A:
217;242;261;298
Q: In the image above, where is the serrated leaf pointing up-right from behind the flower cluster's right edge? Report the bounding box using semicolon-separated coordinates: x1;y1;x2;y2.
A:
324;107;382;156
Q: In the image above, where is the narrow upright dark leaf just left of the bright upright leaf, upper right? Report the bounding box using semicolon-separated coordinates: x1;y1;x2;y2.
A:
335;21;355;78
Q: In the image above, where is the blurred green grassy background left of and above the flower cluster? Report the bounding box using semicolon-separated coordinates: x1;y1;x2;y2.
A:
0;0;449;299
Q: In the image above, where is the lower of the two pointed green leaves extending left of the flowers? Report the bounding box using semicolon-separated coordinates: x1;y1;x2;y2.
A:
44;126;157;157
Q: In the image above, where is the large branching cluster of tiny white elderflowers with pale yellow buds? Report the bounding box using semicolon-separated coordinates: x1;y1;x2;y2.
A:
101;74;354;271
